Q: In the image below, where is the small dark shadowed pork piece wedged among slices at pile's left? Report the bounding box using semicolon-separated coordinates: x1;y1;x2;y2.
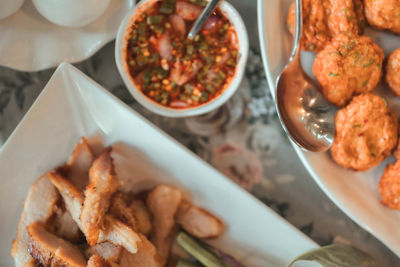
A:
48;206;83;244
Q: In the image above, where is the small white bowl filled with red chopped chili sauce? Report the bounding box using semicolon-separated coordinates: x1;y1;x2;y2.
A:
115;0;248;117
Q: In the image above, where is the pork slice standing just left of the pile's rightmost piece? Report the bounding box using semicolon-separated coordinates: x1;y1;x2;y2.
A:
147;185;182;265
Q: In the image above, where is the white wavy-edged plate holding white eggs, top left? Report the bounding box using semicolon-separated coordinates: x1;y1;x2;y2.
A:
0;0;135;71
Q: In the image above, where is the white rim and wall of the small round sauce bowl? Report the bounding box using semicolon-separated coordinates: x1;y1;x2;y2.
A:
115;0;249;117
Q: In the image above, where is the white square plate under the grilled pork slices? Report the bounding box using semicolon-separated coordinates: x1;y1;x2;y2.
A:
0;63;317;267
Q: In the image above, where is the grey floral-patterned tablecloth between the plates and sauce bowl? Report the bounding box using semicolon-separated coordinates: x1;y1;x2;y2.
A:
0;0;400;266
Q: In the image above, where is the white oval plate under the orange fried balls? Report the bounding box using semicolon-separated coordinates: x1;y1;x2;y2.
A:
258;0;400;256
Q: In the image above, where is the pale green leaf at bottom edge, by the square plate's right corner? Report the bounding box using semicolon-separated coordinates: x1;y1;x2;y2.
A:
288;244;375;267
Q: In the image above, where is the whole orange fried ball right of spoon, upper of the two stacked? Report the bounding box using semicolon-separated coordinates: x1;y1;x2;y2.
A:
313;34;384;107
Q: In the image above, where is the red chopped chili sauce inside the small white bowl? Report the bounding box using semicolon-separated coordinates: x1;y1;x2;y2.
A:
126;0;239;109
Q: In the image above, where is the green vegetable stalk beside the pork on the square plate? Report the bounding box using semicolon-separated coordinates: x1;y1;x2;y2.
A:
176;232;225;267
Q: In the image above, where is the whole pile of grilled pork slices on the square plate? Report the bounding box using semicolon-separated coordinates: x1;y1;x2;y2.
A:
11;138;225;267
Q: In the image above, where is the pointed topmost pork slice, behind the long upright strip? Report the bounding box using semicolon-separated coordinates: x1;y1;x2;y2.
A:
66;137;94;191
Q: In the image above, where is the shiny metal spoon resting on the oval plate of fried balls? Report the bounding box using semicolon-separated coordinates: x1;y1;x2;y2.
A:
276;0;336;152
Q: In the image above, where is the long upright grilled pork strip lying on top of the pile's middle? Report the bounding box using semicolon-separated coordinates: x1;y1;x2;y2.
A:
80;148;120;246
